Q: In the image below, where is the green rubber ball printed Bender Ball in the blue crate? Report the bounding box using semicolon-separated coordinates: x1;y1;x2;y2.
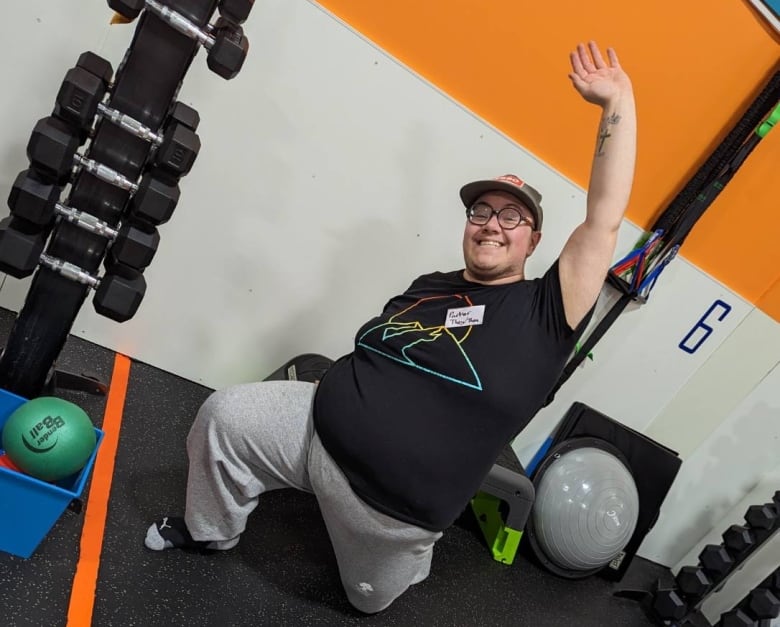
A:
3;396;97;481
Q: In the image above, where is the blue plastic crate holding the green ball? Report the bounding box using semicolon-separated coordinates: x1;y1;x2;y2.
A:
0;389;103;558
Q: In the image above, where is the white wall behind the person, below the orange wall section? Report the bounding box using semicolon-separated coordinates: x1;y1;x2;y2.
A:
0;0;780;612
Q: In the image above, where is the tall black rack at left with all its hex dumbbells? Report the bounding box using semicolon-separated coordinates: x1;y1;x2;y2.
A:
0;0;253;397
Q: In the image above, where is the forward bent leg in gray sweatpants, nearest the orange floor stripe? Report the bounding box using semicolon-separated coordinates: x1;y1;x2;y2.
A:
184;381;315;544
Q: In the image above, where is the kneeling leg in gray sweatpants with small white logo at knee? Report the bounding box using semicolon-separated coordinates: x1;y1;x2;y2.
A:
309;433;442;614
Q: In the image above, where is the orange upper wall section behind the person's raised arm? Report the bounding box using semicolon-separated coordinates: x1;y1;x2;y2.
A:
319;0;780;320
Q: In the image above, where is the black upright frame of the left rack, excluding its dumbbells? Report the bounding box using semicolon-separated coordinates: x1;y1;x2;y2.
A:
0;0;253;398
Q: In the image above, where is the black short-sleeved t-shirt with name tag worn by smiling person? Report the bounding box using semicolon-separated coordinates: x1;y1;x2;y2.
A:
314;262;588;531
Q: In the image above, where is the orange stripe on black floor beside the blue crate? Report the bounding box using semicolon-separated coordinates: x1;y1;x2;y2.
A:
67;355;130;627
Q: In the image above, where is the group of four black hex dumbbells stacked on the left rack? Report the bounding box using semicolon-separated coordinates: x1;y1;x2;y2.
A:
0;52;200;322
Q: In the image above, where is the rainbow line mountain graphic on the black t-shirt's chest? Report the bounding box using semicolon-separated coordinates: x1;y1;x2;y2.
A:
357;294;482;391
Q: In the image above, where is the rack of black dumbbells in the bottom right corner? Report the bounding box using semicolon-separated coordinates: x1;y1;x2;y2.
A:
617;490;780;627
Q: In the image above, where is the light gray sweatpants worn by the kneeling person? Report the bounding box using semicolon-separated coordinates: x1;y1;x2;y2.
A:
180;381;442;613
